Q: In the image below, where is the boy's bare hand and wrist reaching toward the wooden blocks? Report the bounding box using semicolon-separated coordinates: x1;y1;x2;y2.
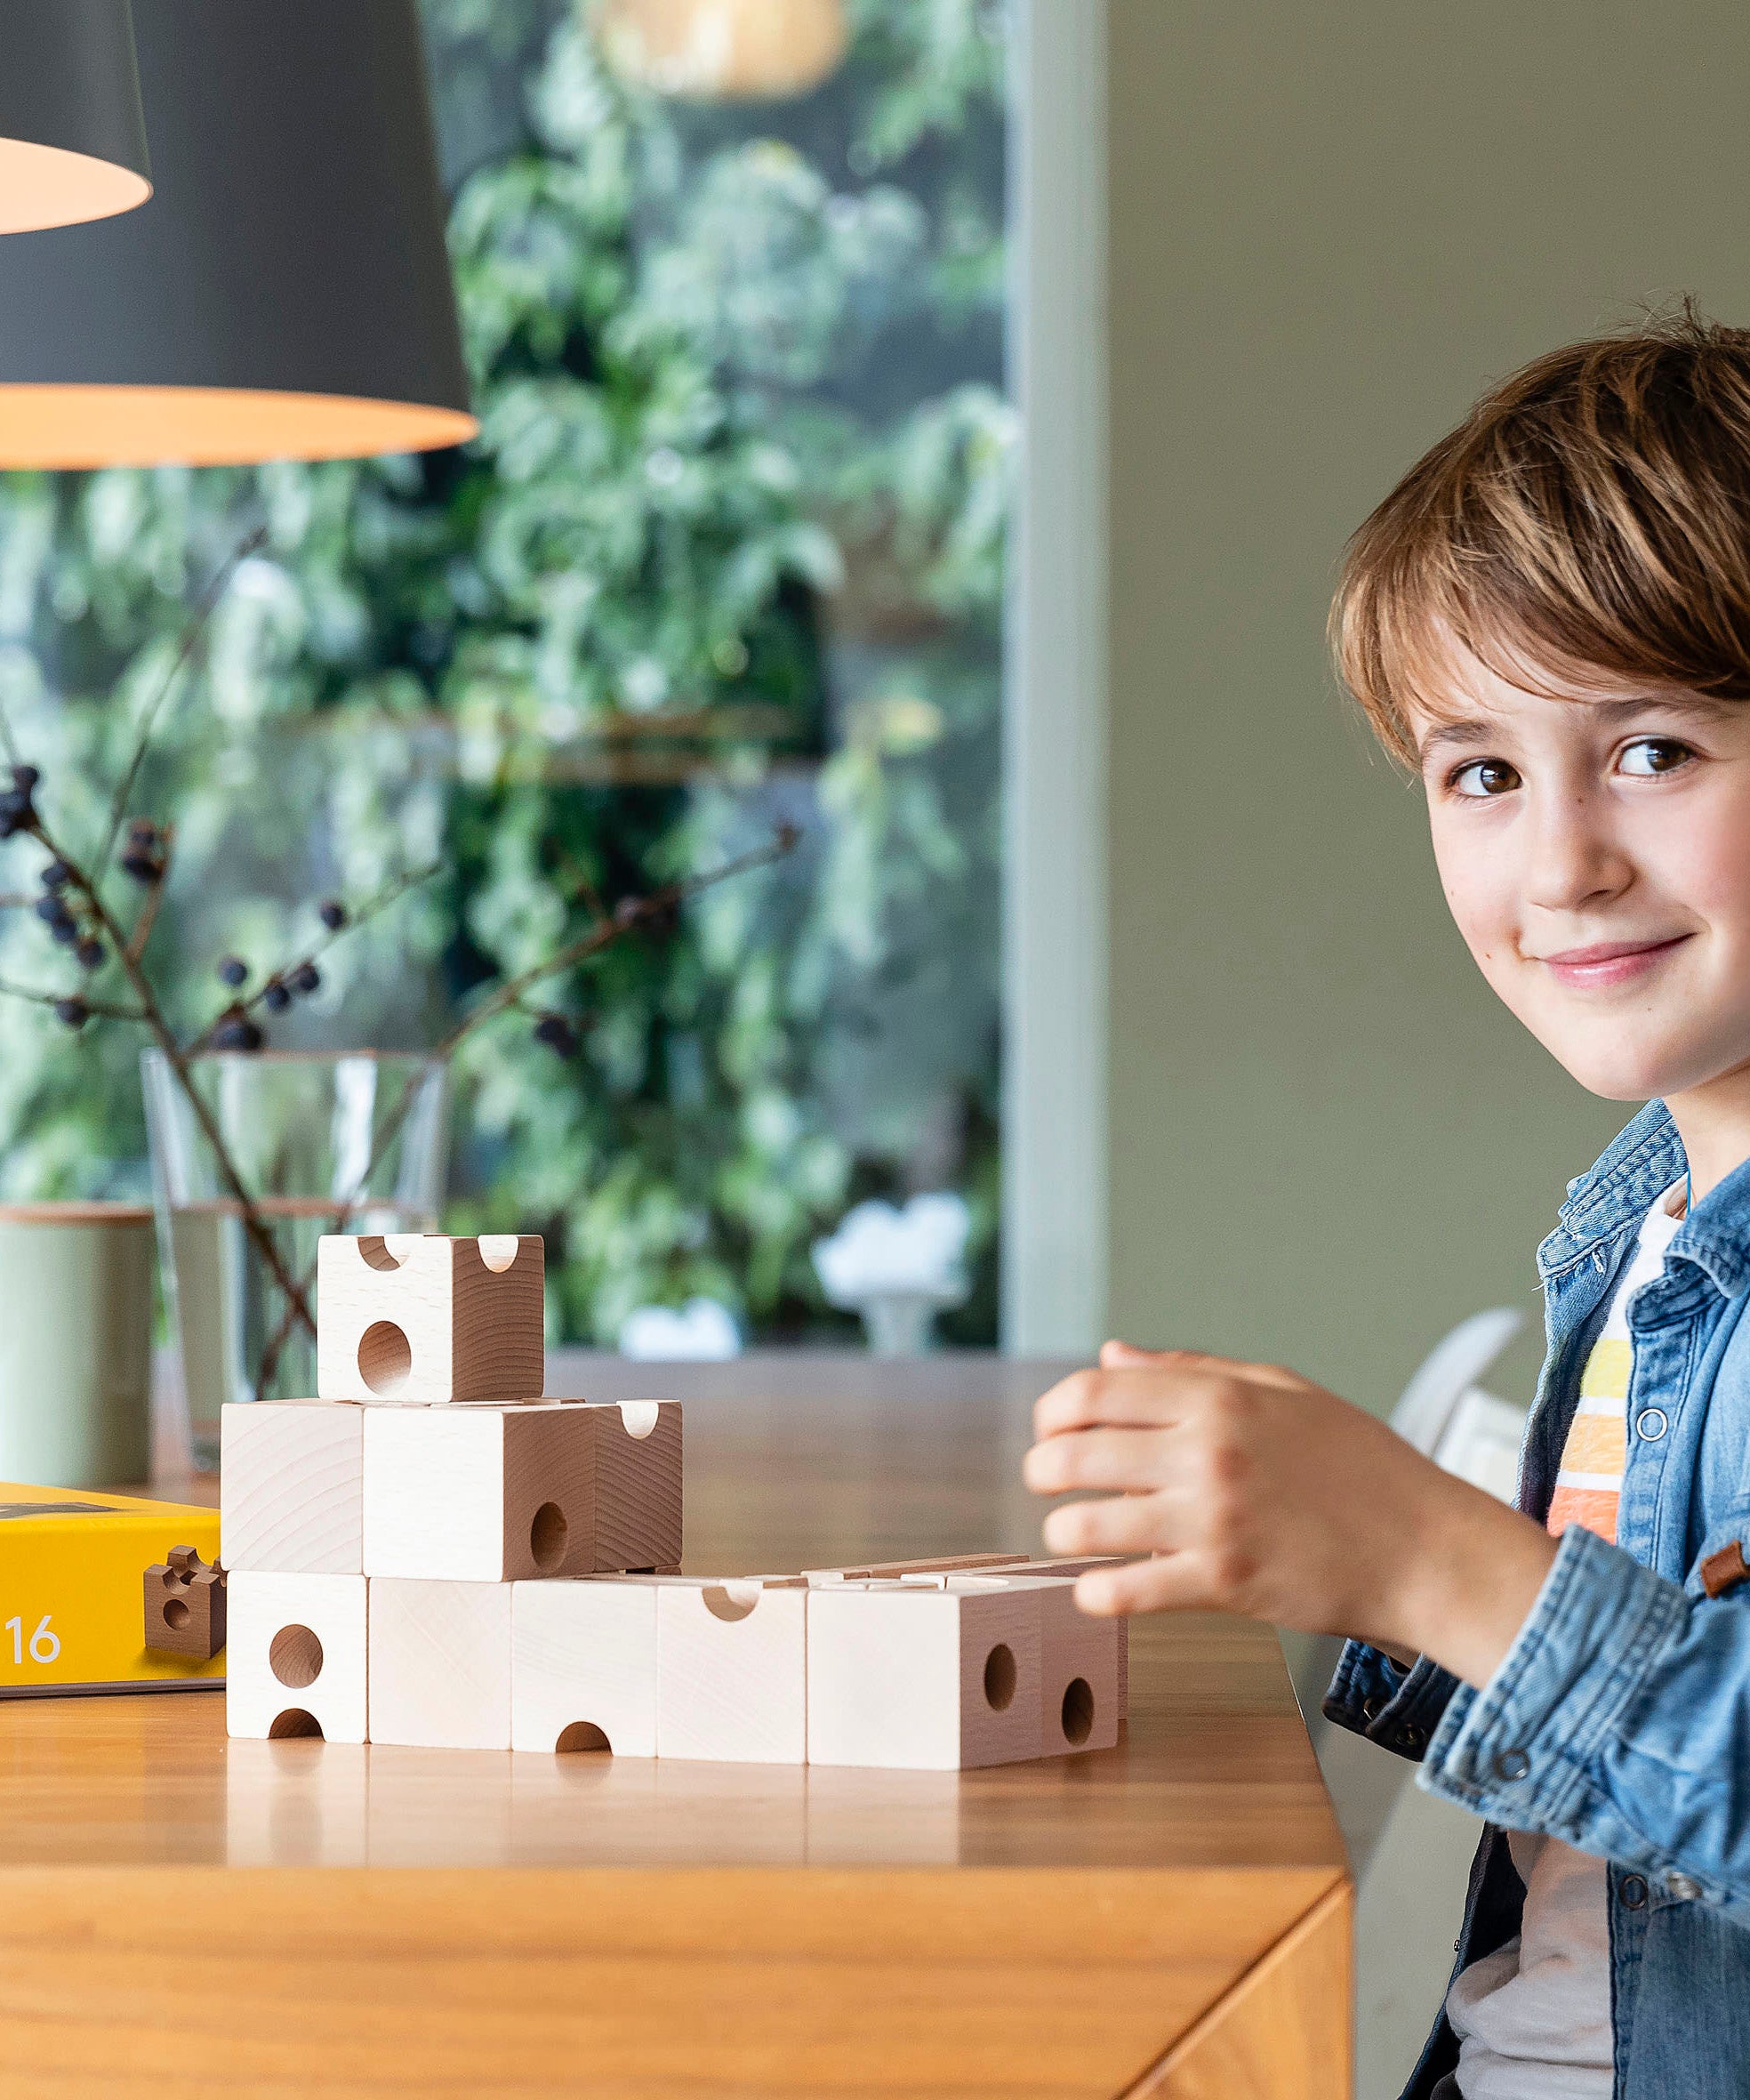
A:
1024;1342;1555;1686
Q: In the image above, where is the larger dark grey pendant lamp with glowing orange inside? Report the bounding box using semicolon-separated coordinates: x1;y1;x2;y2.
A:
0;0;477;466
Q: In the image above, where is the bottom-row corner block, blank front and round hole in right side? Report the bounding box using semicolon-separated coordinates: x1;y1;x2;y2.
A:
807;1575;1049;1773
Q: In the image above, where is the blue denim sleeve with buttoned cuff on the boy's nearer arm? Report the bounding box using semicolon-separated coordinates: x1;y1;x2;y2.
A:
1418;1525;1750;1924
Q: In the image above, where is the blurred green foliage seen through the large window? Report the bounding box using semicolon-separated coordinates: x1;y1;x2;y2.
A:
0;0;1015;1342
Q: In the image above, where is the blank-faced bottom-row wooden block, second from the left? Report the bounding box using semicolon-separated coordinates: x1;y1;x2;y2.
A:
372;1577;514;1750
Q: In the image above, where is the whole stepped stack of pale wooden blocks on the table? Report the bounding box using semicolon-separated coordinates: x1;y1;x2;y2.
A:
222;1235;1127;1770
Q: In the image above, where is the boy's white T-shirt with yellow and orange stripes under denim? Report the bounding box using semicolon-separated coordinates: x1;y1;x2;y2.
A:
1435;1182;1682;2100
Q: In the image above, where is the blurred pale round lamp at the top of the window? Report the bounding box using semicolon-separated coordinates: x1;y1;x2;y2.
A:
594;0;850;101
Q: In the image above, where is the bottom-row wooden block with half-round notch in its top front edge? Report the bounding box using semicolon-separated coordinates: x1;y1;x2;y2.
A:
651;1575;810;1764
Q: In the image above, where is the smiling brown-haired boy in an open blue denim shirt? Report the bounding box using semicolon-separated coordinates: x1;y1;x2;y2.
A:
1026;309;1750;2100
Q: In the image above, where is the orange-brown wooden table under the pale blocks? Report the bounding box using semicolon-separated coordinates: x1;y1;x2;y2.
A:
0;1359;1352;2100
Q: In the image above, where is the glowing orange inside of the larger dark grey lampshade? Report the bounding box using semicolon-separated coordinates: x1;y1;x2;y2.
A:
0;382;478;469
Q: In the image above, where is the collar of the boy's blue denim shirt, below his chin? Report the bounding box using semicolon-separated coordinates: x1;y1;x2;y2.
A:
1538;1100;1750;1298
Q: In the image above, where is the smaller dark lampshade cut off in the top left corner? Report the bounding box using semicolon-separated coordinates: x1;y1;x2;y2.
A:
0;0;151;233
